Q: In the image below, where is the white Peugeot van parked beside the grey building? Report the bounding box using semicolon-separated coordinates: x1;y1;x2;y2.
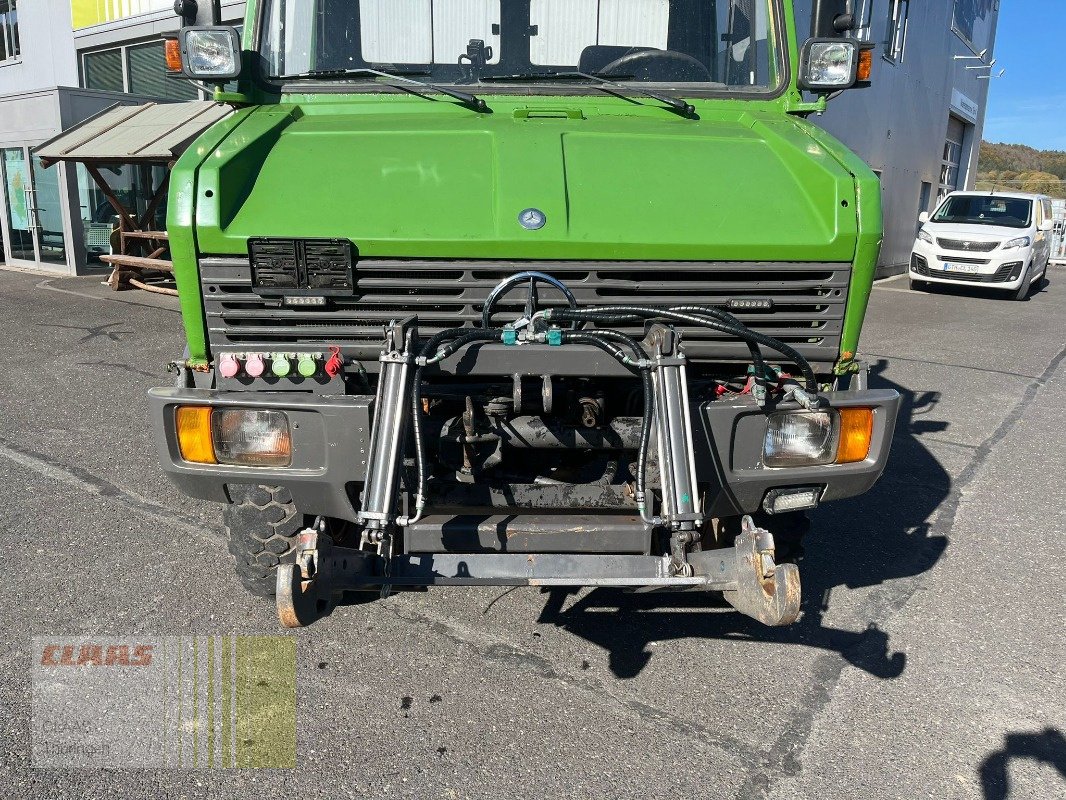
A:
910;192;1054;300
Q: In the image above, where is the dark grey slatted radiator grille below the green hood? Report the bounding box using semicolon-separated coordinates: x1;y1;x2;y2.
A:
200;258;851;364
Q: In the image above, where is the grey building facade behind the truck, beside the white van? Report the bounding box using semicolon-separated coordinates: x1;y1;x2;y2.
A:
795;0;999;275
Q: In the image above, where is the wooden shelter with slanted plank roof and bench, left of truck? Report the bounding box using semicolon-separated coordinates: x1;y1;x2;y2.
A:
34;101;230;294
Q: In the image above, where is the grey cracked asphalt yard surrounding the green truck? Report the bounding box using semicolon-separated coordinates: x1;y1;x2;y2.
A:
0;268;1066;800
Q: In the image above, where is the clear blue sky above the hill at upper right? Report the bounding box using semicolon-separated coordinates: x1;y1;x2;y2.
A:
984;0;1066;150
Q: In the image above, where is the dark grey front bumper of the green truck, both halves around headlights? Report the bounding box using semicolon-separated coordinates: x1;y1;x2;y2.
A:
149;388;900;521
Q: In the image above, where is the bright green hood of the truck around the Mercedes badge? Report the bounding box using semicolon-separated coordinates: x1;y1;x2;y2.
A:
189;96;857;261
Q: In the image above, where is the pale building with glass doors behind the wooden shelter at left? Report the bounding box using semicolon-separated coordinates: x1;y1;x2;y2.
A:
0;0;244;274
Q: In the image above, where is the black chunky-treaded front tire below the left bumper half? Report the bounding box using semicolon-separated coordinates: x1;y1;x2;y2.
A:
222;483;308;597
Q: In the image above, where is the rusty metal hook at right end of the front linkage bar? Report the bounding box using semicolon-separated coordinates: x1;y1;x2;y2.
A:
722;516;801;625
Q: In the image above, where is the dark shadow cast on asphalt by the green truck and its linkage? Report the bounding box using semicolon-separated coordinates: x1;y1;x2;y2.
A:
539;361;951;678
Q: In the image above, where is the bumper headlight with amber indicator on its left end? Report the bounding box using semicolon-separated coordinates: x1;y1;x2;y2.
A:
174;405;292;467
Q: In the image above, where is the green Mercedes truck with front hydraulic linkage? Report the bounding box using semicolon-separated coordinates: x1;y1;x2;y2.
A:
150;0;899;626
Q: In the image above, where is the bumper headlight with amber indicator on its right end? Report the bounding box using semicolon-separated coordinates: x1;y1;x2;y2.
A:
762;407;873;467
